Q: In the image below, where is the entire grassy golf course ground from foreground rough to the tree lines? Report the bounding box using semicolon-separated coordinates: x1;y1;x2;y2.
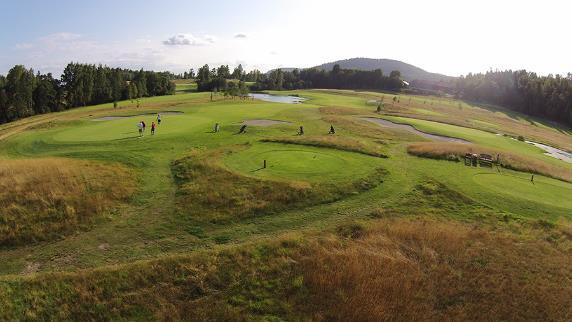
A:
0;87;572;321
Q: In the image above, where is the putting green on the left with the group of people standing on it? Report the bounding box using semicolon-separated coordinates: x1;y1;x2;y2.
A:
54;114;211;142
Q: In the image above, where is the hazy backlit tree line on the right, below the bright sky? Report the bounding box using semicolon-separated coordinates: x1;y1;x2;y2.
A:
455;70;572;125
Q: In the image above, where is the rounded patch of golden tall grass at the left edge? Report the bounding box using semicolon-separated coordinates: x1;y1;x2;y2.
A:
0;158;134;245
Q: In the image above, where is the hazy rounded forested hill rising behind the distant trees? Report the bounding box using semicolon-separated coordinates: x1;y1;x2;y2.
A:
316;58;455;82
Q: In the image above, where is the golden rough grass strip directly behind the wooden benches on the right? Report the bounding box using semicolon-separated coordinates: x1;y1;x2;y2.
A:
407;142;572;182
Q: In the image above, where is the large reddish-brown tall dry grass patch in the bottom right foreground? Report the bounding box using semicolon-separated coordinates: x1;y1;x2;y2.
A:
300;220;572;321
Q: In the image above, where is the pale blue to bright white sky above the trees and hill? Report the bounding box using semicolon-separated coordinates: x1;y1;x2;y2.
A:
0;0;572;76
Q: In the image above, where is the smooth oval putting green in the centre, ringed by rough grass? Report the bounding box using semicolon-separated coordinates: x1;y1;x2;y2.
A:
224;144;379;182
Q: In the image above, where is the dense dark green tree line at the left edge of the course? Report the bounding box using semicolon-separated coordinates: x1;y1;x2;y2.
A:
0;63;175;123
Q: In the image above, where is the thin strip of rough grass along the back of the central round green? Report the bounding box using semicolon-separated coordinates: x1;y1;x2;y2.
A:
261;135;387;158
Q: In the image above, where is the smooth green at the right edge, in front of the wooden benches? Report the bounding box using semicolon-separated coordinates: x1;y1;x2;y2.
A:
473;172;572;209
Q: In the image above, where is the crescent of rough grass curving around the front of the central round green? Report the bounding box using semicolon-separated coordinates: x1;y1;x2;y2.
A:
172;150;384;223
